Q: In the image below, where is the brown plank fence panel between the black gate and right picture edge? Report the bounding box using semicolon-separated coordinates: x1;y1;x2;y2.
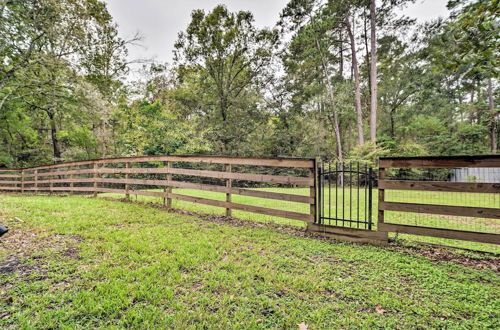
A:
378;155;500;244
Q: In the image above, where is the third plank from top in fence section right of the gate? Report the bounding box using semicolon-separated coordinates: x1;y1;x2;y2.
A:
379;201;500;219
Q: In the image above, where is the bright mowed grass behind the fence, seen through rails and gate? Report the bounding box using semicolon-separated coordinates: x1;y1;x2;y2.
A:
99;186;500;253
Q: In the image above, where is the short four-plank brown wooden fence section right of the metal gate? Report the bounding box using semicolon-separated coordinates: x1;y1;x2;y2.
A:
378;156;500;244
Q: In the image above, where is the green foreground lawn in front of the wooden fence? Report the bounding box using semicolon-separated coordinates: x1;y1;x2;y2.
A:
0;195;500;329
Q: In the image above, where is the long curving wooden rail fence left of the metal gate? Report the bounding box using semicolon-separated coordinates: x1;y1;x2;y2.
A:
0;156;316;222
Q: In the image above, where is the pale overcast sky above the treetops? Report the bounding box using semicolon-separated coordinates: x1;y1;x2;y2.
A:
105;0;447;67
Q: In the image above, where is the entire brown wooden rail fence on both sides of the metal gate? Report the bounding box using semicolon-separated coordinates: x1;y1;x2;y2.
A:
0;156;500;248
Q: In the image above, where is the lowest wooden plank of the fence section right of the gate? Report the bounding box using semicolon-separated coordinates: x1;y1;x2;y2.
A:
378;223;500;244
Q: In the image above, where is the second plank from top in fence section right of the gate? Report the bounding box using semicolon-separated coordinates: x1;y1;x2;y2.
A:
378;180;500;193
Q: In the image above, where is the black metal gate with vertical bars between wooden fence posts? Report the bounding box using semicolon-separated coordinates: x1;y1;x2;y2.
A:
317;163;374;230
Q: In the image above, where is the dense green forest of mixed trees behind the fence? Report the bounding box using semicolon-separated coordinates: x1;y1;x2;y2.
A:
0;0;500;167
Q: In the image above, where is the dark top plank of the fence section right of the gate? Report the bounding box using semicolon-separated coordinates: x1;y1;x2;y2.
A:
379;155;500;168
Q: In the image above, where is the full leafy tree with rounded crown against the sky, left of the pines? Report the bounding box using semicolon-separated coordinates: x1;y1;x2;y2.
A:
175;5;278;154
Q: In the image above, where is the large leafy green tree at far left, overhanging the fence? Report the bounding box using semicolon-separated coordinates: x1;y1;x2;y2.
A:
0;0;129;165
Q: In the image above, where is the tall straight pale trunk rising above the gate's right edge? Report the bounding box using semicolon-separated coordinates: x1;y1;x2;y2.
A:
370;0;377;142
